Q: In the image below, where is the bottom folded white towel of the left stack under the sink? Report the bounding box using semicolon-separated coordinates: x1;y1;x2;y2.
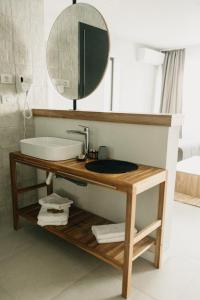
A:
38;206;69;222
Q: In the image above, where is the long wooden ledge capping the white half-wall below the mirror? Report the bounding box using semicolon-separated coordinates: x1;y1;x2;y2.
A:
33;109;183;127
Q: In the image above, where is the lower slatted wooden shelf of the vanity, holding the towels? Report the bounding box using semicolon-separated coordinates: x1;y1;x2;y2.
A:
18;204;155;269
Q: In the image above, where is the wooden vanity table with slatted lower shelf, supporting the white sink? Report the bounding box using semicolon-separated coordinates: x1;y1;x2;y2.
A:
10;152;166;298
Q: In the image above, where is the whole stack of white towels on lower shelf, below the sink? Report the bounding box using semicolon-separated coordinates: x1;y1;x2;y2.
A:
37;193;73;226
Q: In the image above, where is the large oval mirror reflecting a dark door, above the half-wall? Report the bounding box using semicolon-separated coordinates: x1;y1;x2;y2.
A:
47;3;109;100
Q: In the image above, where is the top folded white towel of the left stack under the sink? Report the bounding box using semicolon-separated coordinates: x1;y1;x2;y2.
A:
39;193;73;210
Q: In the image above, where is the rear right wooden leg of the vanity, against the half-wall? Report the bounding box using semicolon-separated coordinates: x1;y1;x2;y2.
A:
154;182;166;268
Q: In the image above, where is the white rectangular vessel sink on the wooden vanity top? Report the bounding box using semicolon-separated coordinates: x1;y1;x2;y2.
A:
20;137;83;161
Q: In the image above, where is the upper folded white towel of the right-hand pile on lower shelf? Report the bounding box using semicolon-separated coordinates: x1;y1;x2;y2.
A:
92;223;137;240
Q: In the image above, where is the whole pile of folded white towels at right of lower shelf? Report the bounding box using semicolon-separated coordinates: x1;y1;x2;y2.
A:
92;223;137;244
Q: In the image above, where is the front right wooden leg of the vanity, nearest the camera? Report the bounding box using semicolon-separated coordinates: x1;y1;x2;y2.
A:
122;189;136;298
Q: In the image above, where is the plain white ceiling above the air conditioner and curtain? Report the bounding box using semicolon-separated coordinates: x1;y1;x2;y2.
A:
87;0;200;49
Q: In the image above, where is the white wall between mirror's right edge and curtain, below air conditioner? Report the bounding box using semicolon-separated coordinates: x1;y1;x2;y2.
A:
111;34;158;113
